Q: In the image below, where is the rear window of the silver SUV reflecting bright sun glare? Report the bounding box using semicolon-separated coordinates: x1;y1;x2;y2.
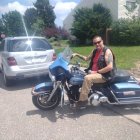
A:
8;38;52;52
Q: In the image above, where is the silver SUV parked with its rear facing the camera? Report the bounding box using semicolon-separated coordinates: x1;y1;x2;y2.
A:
0;36;56;86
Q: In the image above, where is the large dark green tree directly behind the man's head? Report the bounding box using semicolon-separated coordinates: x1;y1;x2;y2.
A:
71;4;112;43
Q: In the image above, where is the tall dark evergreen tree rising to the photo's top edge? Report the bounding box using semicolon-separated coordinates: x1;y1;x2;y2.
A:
33;0;56;28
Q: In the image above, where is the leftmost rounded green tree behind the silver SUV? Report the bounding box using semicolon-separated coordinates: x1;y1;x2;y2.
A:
2;11;25;36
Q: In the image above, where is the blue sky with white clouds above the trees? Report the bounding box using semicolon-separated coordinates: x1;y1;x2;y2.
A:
0;0;80;26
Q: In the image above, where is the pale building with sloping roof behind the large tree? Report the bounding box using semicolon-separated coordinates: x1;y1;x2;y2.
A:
63;0;140;32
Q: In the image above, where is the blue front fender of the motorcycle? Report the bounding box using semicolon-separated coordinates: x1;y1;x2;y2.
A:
31;82;54;96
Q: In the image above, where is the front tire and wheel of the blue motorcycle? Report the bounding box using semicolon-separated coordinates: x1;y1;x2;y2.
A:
32;89;61;111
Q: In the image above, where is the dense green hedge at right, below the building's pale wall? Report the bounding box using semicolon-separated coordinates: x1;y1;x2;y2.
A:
110;19;140;45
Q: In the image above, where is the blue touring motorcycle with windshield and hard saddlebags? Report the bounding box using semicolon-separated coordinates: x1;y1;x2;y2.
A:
31;47;140;110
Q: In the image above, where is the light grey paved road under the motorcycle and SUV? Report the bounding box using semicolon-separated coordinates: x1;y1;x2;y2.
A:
0;74;140;140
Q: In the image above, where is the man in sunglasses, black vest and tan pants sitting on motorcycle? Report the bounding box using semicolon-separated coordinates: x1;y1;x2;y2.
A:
73;36;116;105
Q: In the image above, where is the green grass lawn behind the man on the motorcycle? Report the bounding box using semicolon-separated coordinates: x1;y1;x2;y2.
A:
55;46;140;70
